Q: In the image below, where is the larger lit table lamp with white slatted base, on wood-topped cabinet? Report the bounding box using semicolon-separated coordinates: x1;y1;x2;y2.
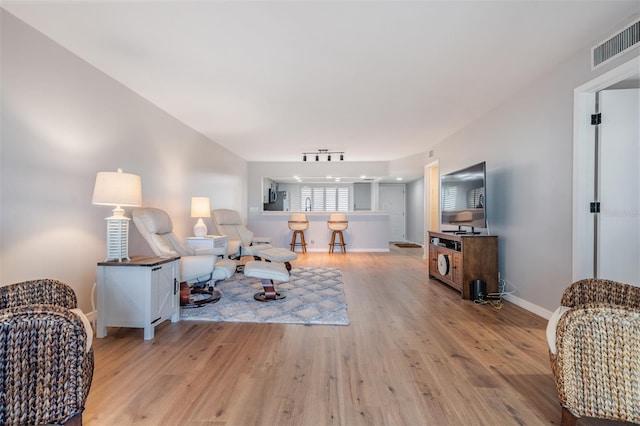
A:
91;169;142;262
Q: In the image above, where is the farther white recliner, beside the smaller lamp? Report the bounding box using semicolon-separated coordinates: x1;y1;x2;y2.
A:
211;209;272;258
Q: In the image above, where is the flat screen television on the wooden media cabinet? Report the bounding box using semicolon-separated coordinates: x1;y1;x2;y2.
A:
440;161;487;233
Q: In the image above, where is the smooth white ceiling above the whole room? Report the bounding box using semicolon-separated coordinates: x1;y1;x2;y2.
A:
2;0;640;161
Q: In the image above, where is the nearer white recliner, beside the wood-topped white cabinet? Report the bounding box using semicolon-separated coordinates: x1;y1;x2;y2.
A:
131;207;236;306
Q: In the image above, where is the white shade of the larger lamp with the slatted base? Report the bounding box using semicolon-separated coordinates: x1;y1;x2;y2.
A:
91;169;142;211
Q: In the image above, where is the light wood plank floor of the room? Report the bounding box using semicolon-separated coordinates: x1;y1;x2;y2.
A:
84;246;624;425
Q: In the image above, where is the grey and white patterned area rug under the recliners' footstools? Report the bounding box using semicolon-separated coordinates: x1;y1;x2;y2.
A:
180;267;349;325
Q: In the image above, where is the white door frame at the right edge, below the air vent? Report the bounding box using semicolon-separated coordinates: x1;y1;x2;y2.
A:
572;57;640;285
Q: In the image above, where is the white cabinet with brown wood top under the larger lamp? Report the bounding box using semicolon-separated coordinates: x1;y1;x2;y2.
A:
96;256;180;340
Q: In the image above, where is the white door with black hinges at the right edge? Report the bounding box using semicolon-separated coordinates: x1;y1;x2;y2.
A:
597;89;640;285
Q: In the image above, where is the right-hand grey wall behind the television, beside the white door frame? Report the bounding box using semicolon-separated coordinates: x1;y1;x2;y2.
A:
434;35;638;315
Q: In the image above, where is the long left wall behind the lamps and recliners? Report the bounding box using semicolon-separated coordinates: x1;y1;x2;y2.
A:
0;10;247;311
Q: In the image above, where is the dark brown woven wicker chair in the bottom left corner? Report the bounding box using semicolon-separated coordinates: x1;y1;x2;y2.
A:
0;279;93;425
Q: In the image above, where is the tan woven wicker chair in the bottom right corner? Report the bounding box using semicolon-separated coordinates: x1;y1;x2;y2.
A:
547;279;640;425
